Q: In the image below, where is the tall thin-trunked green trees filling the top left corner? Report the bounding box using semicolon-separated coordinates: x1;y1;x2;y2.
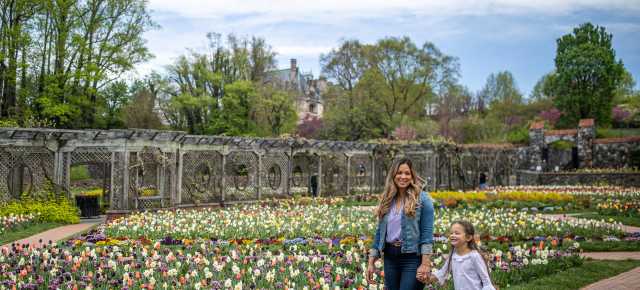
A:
0;0;156;128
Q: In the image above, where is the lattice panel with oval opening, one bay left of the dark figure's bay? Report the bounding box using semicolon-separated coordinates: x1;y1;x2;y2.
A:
260;153;289;197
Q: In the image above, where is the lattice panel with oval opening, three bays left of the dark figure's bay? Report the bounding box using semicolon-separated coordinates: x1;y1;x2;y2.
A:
182;151;222;204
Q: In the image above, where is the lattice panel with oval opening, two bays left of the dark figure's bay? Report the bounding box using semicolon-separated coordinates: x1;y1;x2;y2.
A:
224;151;258;201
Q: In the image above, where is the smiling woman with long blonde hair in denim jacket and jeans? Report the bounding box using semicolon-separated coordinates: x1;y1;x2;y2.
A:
366;158;434;290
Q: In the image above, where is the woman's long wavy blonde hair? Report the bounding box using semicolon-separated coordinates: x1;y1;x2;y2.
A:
375;158;422;219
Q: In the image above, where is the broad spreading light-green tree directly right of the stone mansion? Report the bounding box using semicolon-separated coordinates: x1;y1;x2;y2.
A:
321;37;458;140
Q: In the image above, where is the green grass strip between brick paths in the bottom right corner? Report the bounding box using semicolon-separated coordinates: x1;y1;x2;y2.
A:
506;260;640;290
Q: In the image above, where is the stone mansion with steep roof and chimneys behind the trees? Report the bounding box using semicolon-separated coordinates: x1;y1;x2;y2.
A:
265;58;327;122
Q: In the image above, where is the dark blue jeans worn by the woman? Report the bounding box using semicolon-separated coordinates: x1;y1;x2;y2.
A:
384;244;424;290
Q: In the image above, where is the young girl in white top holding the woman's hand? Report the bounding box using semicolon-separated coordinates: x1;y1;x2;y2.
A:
430;221;496;290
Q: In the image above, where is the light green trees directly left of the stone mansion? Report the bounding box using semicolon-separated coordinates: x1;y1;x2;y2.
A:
161;33;276;134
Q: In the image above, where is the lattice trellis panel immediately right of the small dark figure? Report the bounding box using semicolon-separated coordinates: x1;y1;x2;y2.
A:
320;154;348;196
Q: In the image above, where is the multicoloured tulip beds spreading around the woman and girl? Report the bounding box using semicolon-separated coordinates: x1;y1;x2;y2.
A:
0;187;640;289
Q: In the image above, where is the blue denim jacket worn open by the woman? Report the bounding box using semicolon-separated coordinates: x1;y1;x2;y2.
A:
369;191;434;257
